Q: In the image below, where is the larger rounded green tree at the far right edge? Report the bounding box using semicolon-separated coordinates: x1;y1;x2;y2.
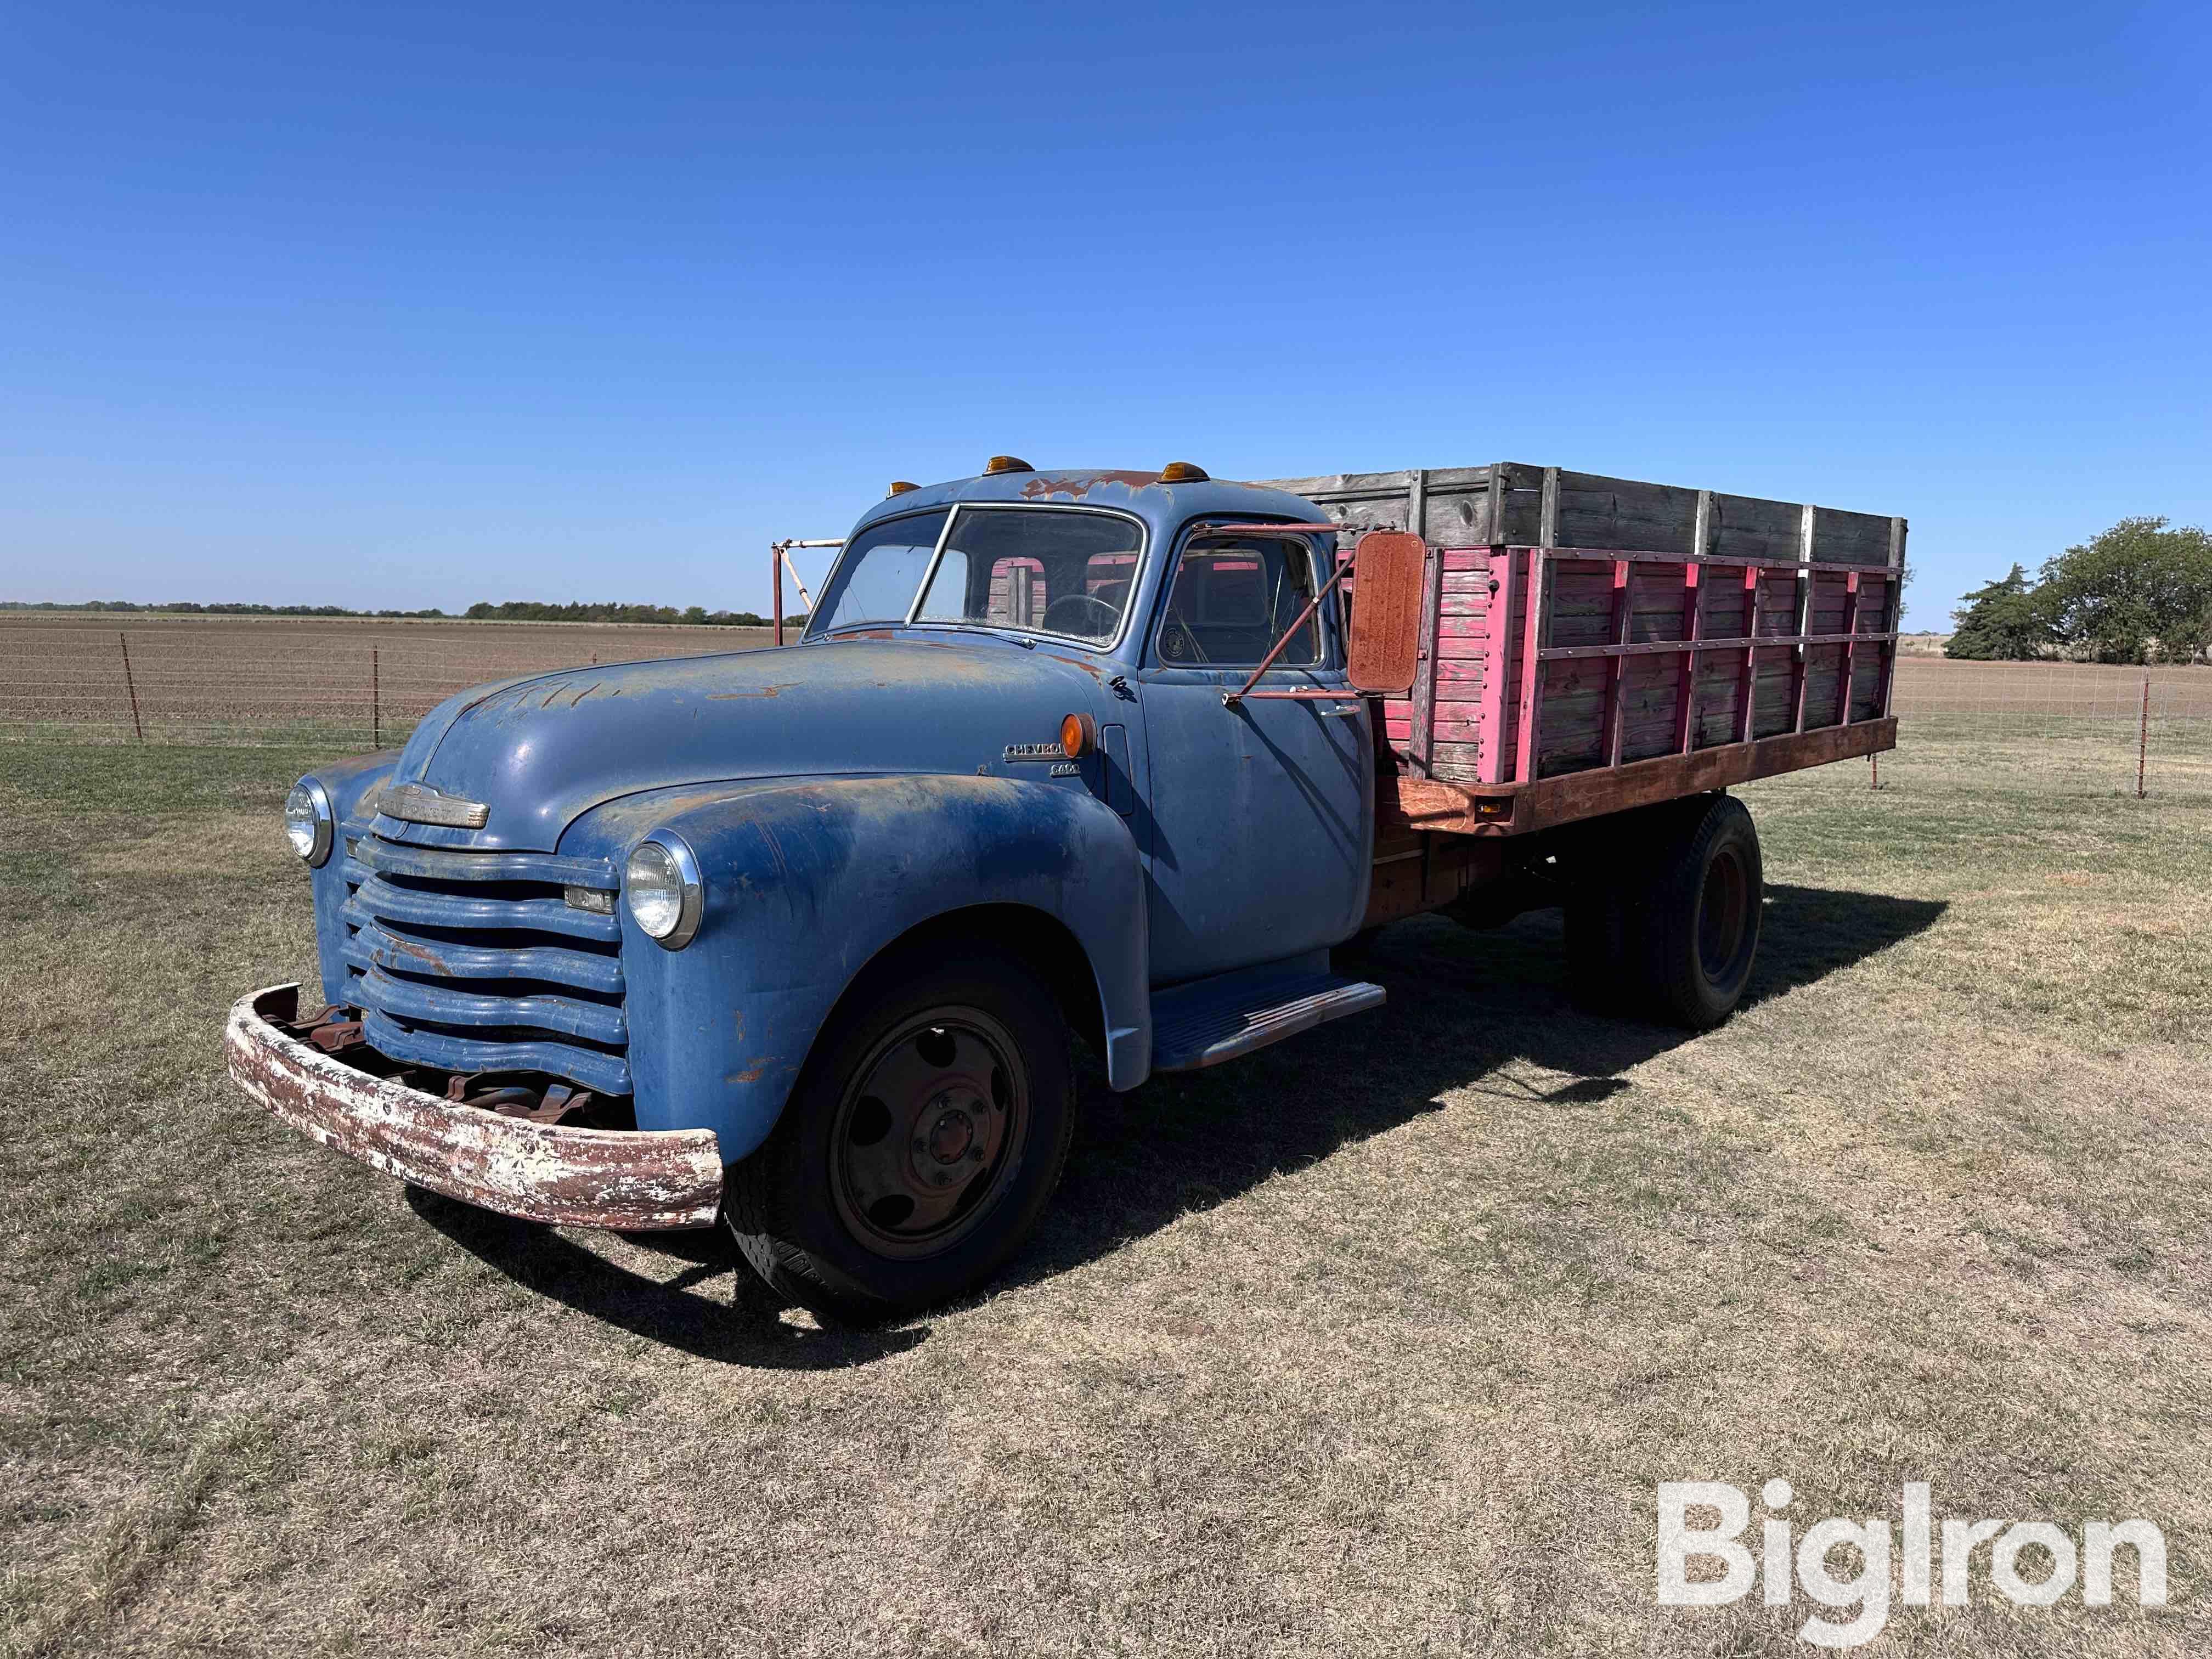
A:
2035;517;2212;664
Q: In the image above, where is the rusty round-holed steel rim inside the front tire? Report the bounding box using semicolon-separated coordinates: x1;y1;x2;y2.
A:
830;1009;1029;1256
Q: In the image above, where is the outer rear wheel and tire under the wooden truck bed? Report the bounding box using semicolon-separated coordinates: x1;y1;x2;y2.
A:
1621;794;1765;1031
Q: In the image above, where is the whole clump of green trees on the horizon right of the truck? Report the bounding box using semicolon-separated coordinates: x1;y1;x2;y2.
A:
1944;517;2212;664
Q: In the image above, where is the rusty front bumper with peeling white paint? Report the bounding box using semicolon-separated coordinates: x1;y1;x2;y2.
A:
223;984;721;1232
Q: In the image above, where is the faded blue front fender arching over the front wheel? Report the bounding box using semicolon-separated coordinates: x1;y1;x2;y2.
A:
588;774;1153;1161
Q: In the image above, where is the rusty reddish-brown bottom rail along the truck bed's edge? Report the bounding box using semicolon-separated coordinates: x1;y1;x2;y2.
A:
1376;714;1898;845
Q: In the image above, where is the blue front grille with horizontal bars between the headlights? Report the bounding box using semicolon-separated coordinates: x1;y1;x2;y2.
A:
332;827;630;1095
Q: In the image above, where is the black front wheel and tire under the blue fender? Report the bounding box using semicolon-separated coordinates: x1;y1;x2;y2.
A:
723;949;1075;1323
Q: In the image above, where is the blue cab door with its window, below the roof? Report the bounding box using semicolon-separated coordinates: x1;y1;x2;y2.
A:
1139;527;1374;984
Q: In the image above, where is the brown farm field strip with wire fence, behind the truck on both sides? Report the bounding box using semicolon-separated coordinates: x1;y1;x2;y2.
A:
0;619;2212;797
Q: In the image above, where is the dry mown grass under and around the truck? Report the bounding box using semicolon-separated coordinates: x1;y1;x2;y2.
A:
0;723;2212;1659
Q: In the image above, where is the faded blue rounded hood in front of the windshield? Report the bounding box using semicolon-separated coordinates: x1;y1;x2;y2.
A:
378;635;1113;851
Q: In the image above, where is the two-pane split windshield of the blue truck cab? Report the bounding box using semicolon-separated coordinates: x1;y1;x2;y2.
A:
808;506;1144;641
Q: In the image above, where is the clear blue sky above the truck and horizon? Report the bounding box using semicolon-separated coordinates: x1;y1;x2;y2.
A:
0;2;2212;626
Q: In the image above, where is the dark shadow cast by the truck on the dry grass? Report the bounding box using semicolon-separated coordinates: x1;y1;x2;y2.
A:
409;887;1944;1369
